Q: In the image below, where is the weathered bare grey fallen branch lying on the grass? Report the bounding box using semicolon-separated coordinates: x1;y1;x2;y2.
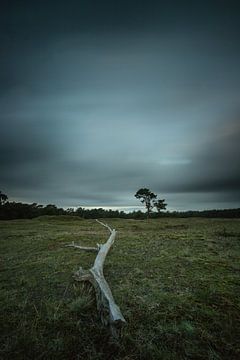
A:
65;220;126;338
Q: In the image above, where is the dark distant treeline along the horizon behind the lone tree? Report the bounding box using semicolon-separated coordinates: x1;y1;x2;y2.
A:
0;201;240;220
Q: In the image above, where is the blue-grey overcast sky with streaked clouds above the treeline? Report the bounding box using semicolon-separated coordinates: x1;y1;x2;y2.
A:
0;0;240;210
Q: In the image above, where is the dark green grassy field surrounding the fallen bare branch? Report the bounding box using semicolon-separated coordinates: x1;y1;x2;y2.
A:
0;217;240;360
